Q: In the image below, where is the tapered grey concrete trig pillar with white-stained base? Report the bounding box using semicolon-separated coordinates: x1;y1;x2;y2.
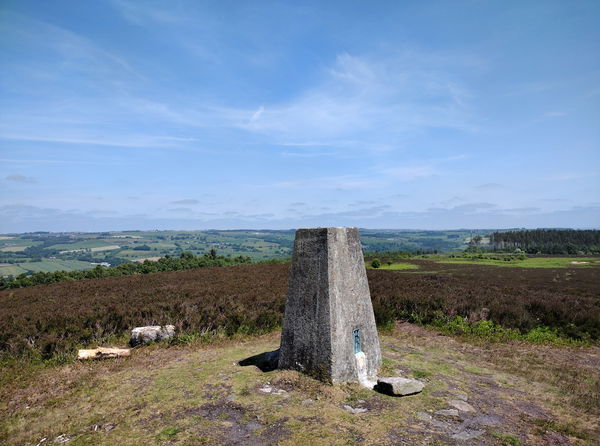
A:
279;228;381;388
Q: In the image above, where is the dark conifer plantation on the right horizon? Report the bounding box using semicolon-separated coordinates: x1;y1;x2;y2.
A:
490;229;600;254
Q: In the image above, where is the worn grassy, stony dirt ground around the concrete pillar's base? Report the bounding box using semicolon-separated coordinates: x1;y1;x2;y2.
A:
0;324;600;446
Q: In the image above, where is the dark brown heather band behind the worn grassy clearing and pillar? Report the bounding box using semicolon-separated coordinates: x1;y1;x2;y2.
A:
0;257;600;359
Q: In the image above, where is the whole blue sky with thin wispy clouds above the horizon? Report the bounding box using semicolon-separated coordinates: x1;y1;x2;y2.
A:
0;0;600;232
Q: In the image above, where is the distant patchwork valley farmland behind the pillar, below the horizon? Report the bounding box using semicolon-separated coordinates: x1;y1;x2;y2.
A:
0;229;478;275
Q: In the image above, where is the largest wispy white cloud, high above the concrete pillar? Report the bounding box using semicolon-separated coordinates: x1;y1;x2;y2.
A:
240;52;476;145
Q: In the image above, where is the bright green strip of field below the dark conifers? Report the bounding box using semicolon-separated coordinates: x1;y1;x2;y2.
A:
431;257;600;268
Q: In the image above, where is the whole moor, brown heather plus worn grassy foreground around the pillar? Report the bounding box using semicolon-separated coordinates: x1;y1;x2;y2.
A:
0;254;600;445
